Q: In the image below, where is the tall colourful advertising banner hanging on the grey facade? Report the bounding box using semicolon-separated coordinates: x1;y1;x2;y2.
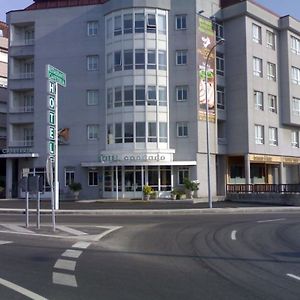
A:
197;16;216;122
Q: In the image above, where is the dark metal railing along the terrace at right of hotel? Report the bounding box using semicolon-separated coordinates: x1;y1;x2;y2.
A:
227;184;300;194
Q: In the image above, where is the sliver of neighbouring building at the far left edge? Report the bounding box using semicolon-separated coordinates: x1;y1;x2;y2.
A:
0;22;8;198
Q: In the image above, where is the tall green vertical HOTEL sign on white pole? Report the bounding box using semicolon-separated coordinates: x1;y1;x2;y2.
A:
46;65;67;212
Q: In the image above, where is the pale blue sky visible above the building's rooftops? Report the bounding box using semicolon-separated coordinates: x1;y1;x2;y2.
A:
0;0;300;21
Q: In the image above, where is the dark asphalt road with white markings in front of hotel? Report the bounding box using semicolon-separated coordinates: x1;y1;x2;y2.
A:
0;213;300;300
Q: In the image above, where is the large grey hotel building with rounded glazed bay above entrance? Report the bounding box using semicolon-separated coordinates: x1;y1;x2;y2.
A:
6;0;300;202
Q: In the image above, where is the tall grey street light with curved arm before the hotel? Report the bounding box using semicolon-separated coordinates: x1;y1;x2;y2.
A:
205;38;225;208
